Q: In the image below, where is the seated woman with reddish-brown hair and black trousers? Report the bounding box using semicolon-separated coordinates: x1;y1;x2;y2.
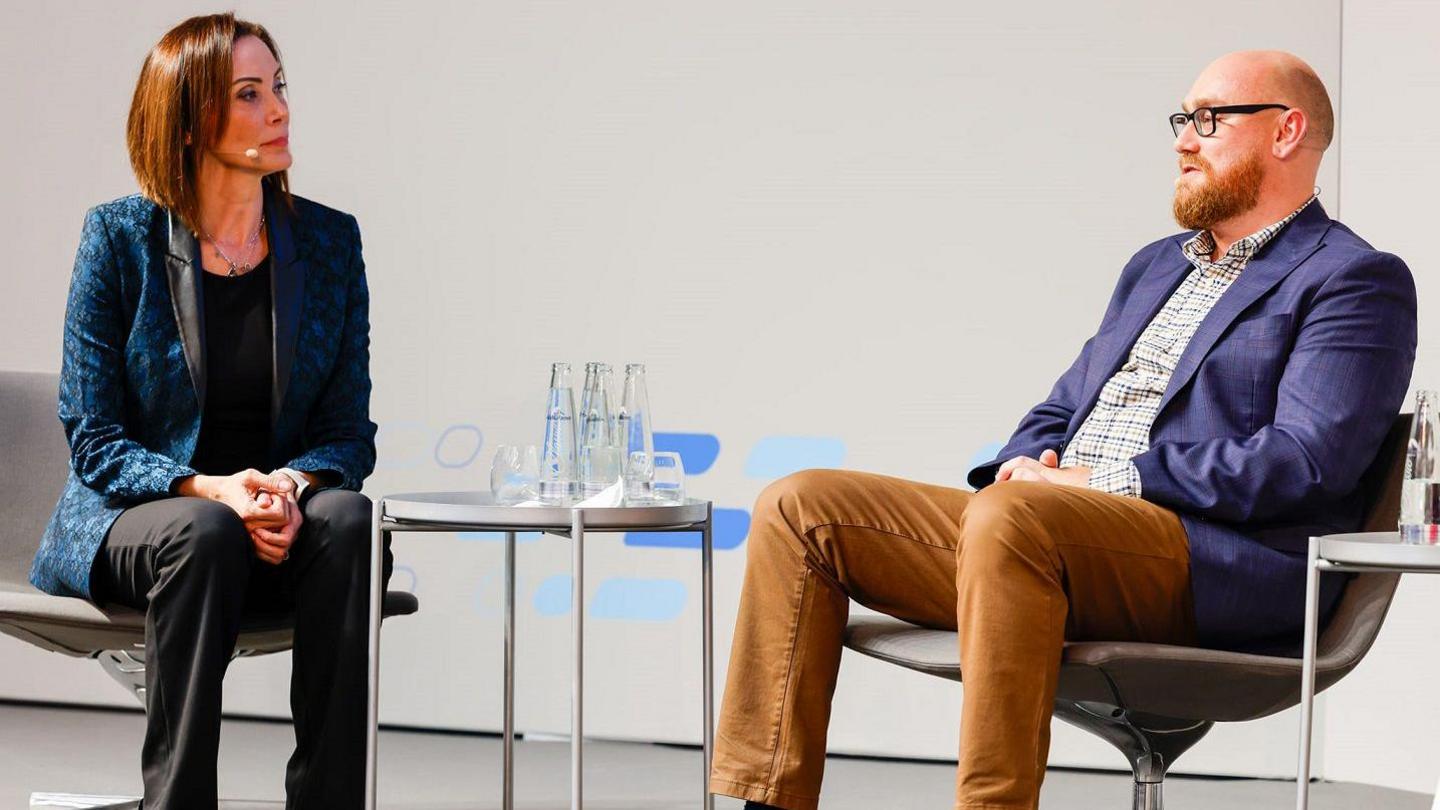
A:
30;14;390;810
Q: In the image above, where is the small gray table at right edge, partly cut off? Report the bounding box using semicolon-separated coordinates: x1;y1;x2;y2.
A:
1295;532;1440;810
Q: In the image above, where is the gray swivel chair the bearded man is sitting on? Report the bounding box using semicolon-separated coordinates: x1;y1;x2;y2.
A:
845;414;1410;810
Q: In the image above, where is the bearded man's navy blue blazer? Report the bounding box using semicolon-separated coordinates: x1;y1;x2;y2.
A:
969;200;1416;649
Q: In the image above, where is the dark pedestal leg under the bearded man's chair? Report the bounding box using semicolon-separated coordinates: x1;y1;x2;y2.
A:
1056;700;1215;810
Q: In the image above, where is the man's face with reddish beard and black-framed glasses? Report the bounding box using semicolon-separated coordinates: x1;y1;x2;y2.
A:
1174;63;1276;229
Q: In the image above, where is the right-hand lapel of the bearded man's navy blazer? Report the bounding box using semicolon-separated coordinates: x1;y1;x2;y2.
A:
1156;200;1331;412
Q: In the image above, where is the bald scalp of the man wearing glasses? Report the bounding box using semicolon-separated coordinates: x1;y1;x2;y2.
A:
1192;50;1335;151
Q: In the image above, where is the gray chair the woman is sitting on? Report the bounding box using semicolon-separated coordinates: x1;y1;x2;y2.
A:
0;372;419;801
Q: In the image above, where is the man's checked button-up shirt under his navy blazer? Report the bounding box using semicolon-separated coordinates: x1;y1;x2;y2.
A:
1060;196;1315;497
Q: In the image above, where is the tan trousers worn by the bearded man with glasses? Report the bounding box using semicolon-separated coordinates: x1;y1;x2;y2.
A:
711;470;1195;810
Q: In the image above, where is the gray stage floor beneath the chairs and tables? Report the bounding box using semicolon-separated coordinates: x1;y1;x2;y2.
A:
0;703;1431;810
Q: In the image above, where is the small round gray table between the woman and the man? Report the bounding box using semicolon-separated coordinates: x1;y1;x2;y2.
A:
366;491;714;810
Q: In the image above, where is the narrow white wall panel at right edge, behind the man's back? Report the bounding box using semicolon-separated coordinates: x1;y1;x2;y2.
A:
1325;0;1440;793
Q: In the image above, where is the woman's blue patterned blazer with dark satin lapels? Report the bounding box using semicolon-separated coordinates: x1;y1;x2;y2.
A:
30;184;376;598
